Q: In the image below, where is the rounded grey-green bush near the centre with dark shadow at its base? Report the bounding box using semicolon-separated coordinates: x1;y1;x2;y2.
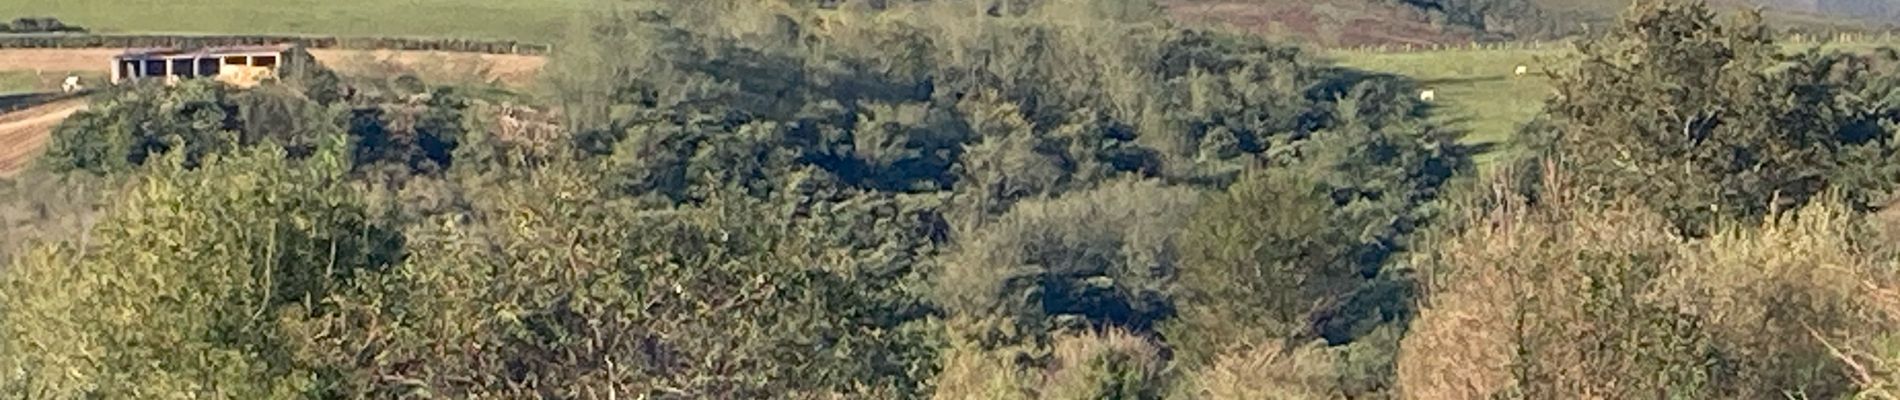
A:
935;180;1197;345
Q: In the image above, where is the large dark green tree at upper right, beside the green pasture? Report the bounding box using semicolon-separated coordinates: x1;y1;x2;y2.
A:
1531;2;1900;235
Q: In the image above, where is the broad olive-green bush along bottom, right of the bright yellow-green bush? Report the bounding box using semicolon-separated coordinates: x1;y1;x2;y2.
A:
279;161;941;398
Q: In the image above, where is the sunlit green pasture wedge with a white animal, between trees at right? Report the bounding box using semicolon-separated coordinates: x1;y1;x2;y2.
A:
1332;49;1562;165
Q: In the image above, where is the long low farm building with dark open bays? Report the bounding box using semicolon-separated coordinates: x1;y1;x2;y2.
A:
112;44;315;87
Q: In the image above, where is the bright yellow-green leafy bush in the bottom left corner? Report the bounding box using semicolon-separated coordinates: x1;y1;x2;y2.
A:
0;142;366;398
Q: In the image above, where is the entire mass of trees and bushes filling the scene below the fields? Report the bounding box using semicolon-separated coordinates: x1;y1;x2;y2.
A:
0;0;1900;400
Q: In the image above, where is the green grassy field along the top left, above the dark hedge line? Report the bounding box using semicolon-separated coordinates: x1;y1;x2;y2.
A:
0;0;610;44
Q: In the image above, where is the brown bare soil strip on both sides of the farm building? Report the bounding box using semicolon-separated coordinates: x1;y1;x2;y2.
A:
0;49;547;87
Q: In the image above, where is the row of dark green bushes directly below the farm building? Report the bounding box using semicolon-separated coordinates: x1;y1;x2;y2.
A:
36;80;469;174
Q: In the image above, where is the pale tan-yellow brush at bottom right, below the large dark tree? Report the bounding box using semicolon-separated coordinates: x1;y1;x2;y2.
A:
1398;170;1900;398
